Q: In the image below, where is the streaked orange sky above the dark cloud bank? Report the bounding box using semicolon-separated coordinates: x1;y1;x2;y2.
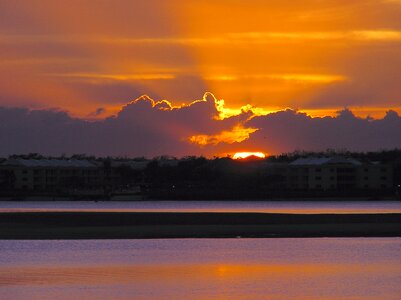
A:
0;0;401;118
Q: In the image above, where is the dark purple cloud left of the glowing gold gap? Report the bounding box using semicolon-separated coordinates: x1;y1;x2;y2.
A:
0;97;225;157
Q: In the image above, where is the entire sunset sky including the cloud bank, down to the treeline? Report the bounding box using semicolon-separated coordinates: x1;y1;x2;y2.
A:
0;0;401;156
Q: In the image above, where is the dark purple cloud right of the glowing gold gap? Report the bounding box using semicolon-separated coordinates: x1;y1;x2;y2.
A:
242;109;401;153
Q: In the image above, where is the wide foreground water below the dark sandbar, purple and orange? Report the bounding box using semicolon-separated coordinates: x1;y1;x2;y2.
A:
0;238;401;300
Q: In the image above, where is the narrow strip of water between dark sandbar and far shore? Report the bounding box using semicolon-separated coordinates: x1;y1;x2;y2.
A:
0;200;401;213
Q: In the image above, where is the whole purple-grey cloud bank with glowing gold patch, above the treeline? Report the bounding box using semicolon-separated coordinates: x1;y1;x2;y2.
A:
0;93;401;157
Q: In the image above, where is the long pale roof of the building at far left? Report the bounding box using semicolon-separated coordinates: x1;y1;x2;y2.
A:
0;158;96;168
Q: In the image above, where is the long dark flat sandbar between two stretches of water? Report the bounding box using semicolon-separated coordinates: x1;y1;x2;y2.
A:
0;212;401;239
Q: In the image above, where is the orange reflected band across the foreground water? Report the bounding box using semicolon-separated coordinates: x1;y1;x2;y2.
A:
0;263;401;286
